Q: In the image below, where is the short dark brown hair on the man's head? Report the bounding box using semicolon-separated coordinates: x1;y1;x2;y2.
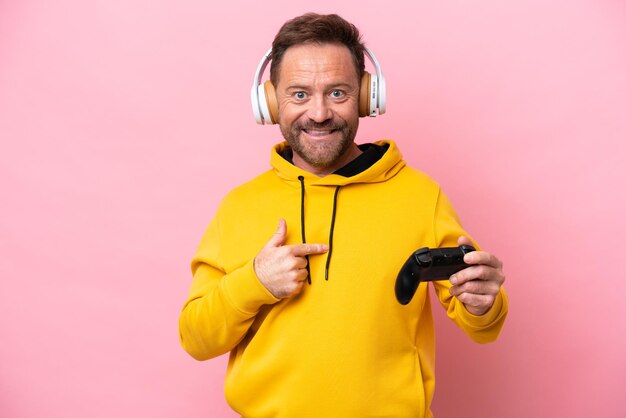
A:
270;13;365;86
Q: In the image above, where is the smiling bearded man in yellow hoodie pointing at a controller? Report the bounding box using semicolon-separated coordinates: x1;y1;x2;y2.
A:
180;14;507;417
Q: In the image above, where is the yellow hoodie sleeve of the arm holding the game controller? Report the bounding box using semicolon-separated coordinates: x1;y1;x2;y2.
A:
432;189;508;343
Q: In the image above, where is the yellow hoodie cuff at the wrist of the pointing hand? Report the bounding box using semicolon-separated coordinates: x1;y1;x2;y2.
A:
221;259;280;315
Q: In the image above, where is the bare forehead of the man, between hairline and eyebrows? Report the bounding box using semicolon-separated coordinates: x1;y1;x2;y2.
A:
278;44;359;88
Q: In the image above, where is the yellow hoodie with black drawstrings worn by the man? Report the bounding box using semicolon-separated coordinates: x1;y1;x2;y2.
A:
180;141;507;418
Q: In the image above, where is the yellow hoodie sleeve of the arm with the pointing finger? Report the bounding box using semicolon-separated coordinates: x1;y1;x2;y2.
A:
179;207;279;360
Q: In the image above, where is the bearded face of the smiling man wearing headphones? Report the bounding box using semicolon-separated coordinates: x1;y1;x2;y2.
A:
276;44;359;173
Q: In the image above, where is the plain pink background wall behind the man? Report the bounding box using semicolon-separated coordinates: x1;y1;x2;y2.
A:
0;0;626;418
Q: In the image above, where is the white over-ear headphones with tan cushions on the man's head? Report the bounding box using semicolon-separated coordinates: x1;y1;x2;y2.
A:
250;47;387;125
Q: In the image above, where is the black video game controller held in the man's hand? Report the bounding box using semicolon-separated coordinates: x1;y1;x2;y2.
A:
396;245;476;305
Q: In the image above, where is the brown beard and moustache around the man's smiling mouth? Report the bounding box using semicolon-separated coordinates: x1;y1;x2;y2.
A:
280;119;359;168
